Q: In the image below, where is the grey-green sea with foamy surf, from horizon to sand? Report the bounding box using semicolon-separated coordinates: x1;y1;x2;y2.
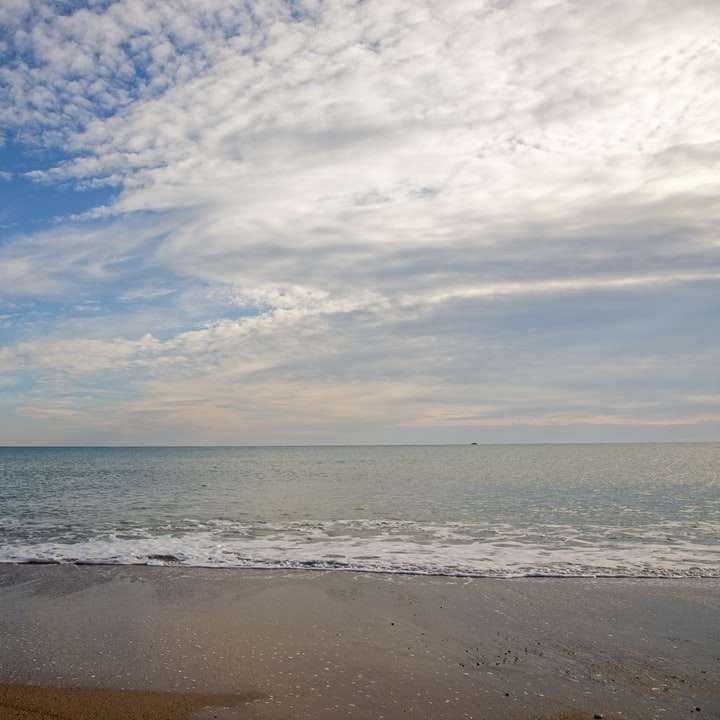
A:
0;443;720;577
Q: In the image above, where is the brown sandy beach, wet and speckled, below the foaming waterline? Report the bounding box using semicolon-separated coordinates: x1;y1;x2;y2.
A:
0;565;720;720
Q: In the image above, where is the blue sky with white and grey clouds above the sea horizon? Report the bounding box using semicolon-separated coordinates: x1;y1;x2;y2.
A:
0;0;720;445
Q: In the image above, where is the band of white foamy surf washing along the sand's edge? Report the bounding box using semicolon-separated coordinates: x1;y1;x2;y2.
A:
0;519;720;578
